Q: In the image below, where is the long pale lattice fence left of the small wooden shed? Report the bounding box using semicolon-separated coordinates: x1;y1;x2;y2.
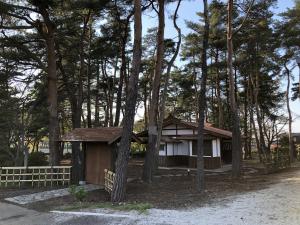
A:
0;166;71;187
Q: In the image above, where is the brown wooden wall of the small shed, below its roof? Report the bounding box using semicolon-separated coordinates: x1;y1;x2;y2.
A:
85;143;112;185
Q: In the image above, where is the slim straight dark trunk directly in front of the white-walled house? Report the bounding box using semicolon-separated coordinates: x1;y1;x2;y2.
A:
196;0;209;192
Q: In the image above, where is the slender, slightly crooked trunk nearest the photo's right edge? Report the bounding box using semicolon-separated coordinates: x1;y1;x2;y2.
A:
284;62;295;162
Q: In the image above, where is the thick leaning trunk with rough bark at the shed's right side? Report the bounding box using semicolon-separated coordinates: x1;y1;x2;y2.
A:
111;0;142;202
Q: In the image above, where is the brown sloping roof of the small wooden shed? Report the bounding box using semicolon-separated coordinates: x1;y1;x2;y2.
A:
61;127;140;144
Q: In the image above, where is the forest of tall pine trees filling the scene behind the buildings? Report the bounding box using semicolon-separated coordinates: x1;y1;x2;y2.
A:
0;0;300;201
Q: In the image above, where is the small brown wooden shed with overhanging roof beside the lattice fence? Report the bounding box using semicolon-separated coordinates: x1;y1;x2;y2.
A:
61;127;139;185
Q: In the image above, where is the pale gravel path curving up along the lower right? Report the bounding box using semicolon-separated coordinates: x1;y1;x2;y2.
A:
87;171;300;225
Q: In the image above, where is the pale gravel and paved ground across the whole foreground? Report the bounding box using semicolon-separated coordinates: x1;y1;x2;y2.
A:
0;171;300;225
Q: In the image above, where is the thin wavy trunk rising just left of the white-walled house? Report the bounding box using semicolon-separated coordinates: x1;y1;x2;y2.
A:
155;0;181;161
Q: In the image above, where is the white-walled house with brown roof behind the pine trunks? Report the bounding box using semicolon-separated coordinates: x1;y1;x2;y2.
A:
139;116;232;169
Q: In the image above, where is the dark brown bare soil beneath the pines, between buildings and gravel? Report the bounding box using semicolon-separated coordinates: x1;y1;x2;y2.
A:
0;158;300;211
